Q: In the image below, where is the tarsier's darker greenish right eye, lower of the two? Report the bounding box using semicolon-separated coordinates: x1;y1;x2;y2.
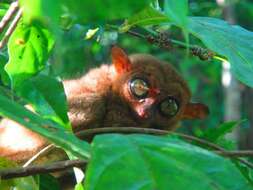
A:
159;97;179;117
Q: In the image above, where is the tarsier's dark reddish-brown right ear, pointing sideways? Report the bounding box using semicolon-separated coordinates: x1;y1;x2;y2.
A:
183;103;209;119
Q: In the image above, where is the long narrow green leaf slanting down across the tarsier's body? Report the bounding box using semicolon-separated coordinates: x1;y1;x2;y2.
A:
0;91;90;159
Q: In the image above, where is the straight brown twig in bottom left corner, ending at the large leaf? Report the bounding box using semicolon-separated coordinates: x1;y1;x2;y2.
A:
0;160;87;179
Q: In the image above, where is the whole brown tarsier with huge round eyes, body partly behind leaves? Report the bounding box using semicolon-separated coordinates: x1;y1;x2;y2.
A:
0;46;208;161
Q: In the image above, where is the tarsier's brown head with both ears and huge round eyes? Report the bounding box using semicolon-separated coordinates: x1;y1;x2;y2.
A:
112;46;208;129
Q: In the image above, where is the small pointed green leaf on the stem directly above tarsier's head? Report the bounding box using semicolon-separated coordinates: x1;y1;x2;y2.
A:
119;7;169;32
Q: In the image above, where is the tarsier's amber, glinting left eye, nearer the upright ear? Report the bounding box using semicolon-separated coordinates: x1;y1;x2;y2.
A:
129;78;149;98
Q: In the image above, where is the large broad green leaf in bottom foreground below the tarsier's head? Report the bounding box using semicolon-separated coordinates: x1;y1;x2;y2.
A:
84;135;253;190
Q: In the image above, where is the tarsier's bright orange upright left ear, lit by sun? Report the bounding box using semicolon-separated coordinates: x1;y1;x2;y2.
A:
111;46;131;74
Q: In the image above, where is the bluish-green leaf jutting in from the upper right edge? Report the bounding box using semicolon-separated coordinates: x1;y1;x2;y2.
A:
188;17;253;87
